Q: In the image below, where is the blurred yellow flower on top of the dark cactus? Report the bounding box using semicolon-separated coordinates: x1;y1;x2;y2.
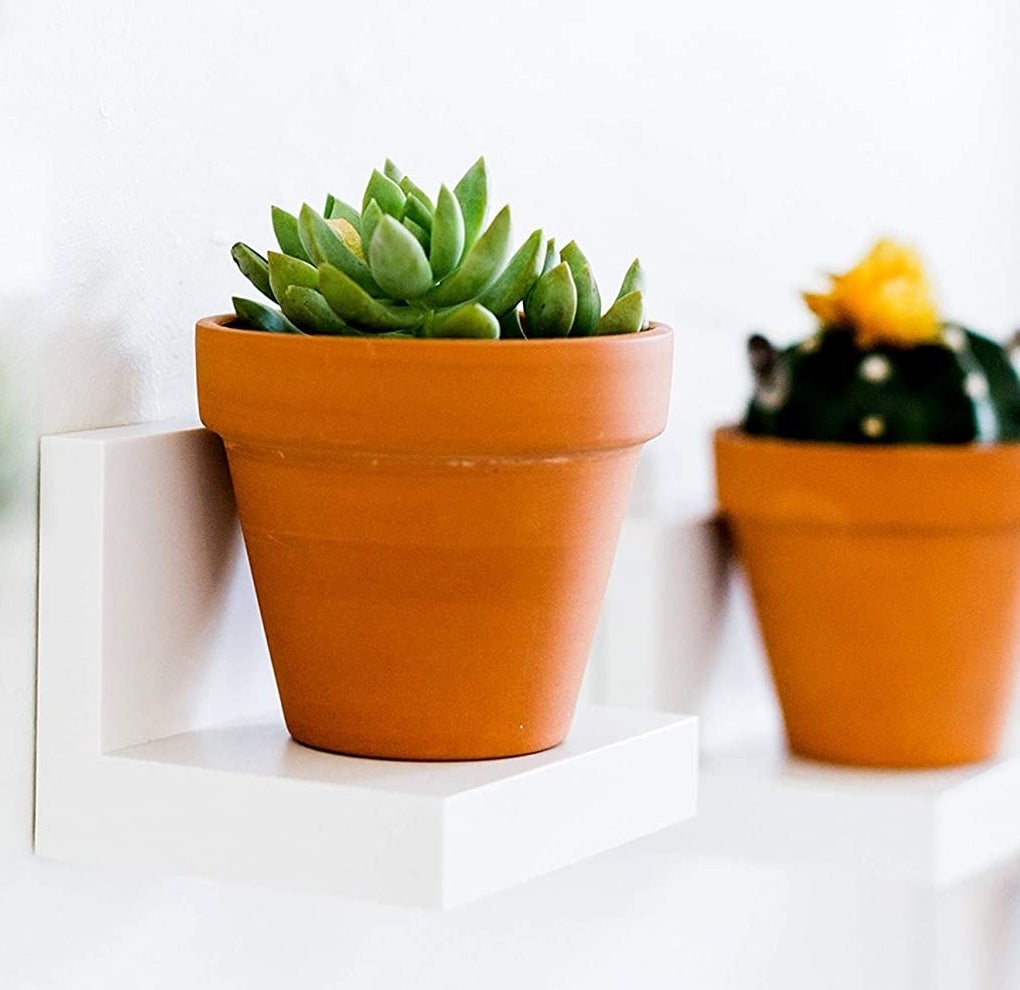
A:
803;240;941;347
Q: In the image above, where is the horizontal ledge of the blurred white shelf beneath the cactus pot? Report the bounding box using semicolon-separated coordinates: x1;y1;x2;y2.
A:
665;748;1020;887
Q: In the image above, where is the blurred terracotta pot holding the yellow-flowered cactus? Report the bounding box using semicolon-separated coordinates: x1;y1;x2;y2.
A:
715;430;1020;768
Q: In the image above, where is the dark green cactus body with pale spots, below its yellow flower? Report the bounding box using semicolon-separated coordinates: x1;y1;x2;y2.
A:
744;323;1020;444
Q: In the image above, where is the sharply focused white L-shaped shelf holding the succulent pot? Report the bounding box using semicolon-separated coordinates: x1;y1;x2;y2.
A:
36;425;698;906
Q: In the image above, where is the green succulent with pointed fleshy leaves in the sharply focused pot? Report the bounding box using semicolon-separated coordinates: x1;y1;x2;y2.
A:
231;158;647;337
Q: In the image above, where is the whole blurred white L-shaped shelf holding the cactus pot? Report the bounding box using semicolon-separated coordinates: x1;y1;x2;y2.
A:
588;506;1020;887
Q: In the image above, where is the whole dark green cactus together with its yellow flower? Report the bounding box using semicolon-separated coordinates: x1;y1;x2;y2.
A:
744;241;1020;444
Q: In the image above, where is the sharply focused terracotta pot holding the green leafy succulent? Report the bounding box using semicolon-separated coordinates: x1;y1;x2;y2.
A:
197;317;672;760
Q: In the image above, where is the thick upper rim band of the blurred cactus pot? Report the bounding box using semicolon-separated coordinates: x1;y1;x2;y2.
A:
714;427;1020;532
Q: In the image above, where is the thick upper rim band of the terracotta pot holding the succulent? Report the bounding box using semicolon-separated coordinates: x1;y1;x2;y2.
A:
195;314;673;458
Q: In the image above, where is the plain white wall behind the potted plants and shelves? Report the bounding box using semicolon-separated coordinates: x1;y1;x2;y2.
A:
0;0;1020;990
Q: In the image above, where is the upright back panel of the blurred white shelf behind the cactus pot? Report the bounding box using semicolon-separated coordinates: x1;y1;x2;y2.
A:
584;513;781;752
